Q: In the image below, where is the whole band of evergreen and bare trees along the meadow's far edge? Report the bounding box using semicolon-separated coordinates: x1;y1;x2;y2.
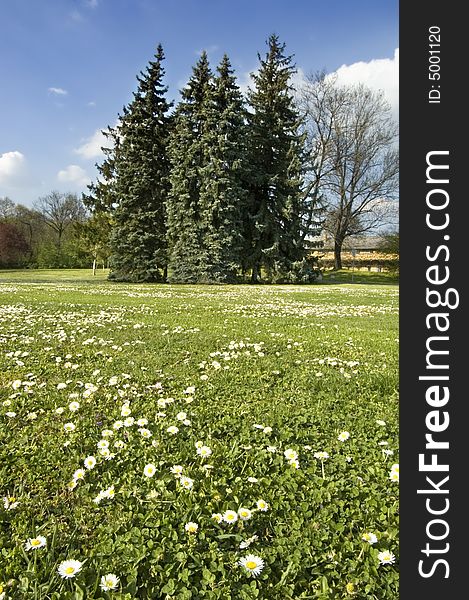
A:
0;35;398;283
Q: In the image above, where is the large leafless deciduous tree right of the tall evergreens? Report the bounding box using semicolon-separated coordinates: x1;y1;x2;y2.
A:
299;73;399;269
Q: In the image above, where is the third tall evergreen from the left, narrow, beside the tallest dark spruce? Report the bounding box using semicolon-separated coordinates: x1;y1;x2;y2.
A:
200;54;246;283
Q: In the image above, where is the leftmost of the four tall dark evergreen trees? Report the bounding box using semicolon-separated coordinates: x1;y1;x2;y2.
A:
108;45;171;281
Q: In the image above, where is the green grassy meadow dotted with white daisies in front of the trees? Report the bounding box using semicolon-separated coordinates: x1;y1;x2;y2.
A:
0;271;399;600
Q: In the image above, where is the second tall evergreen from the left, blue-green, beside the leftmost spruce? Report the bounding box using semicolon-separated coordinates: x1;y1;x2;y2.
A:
167;52;213;283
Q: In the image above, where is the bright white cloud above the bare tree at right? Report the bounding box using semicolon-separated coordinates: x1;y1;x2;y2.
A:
335;48;399;119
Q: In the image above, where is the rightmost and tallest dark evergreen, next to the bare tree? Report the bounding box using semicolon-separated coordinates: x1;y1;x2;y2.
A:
243;35;304;282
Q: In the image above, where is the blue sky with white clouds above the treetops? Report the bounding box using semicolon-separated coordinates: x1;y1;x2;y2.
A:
0;0;399;206
